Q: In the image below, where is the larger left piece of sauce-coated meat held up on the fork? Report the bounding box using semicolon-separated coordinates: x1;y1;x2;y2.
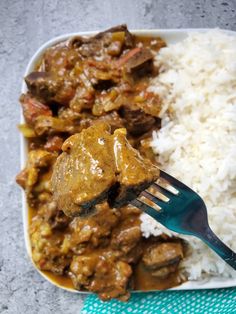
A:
52;126;115;216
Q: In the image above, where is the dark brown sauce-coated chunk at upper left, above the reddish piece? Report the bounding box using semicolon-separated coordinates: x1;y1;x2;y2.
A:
25;72;76;105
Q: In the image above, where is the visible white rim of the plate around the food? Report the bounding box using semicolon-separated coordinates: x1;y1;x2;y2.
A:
19;27;236;294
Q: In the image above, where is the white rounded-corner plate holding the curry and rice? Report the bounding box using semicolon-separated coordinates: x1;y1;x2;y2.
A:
20;29;236;294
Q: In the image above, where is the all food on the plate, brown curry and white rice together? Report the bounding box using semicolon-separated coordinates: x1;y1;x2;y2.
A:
17;25;236;300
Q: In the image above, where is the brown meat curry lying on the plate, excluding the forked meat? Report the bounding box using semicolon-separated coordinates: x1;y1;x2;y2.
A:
17;26;183;300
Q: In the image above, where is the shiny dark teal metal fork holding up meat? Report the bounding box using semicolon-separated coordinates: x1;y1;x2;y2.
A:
131;170;236;270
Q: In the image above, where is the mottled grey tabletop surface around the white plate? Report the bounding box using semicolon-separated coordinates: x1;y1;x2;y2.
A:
0;0;236;314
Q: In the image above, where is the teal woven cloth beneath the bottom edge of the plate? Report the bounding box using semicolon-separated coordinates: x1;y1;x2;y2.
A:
82;288;236;314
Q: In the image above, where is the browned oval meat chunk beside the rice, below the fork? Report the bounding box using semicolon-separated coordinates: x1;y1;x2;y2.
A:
142;242;184;269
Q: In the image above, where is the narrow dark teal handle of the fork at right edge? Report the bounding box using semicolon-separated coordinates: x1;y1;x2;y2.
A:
198;227;236;270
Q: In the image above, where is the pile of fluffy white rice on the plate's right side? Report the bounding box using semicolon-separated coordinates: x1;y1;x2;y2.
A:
141;30;236;280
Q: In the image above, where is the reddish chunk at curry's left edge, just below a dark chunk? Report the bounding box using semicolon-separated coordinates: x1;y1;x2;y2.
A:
20;94;52;126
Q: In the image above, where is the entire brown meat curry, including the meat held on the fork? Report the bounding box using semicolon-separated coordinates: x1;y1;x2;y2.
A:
16;25;184;300
